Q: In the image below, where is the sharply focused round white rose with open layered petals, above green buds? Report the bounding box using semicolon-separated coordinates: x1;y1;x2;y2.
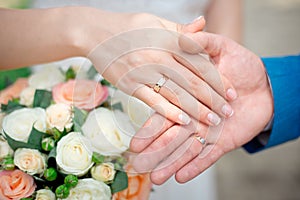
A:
56;132;94;176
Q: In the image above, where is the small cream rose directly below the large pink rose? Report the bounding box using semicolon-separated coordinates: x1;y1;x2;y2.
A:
46;103;73;131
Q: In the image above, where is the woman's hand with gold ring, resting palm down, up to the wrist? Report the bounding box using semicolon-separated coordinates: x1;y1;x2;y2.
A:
77;8;236;125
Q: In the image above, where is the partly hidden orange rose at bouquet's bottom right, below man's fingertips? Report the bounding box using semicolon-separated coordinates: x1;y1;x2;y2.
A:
113;166;152;200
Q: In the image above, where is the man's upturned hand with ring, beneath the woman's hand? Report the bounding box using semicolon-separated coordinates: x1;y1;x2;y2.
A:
131;32;273;184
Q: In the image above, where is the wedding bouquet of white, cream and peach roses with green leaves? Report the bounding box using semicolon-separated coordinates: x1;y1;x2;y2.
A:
0;58;151;200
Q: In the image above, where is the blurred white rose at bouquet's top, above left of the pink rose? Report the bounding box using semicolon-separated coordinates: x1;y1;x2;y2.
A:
28;64;65;90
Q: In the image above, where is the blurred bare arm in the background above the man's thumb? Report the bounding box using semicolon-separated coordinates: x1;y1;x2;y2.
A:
205;0;243;42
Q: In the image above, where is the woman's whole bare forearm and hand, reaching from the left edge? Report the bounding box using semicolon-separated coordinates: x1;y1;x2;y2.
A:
0;7;236;125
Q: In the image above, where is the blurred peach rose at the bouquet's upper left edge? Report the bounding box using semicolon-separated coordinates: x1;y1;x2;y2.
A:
0;78;28;104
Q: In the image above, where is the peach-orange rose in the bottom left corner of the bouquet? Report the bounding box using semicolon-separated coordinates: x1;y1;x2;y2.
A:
0;170;36;200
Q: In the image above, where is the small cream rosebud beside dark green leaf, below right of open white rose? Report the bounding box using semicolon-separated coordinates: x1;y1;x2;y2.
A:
91;162;116;182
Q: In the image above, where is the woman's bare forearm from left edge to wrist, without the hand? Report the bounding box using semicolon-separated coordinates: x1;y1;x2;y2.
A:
0;7;119;69
